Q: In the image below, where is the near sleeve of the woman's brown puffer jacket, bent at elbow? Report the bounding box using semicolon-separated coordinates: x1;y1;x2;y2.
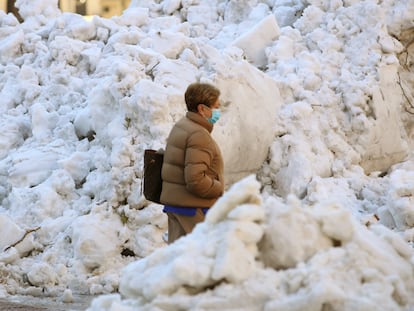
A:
184;131;224;199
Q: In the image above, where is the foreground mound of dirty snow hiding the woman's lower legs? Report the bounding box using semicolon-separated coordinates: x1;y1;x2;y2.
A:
88;177;414;311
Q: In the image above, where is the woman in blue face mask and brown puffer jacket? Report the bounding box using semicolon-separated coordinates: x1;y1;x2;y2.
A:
161;83;224;243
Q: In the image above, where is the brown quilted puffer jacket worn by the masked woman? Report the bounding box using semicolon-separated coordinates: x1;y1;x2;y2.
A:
161;112;224;207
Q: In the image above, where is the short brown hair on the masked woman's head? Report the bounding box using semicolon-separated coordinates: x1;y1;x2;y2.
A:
184;83;220;112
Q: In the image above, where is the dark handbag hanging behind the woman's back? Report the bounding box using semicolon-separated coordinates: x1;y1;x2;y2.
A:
144;149;164;204
